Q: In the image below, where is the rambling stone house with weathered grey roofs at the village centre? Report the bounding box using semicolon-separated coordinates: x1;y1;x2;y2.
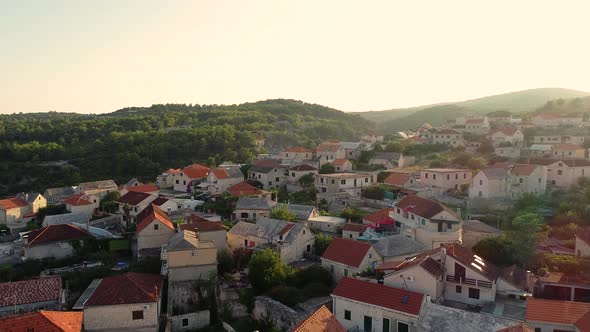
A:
227;218;315;263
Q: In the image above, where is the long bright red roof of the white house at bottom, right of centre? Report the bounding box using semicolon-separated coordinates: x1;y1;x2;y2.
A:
332;277;424;316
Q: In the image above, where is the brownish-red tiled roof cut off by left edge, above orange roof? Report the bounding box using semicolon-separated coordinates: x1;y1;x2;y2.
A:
0;277;62;308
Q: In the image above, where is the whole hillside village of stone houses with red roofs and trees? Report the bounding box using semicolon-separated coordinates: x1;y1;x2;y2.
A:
0;112;590;332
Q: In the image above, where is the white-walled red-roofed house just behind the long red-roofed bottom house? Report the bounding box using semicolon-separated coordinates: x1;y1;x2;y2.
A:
321;237;381;281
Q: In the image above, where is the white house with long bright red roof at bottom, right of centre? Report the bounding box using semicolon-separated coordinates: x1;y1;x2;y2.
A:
332;278;426;332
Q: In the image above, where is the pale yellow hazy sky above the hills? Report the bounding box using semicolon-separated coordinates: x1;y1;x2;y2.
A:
0;0;590;113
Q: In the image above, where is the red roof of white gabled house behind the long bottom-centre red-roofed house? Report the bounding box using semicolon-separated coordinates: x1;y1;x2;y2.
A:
322;237;371;267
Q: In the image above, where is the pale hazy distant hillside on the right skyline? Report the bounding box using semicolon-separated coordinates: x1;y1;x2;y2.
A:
356;88;590;133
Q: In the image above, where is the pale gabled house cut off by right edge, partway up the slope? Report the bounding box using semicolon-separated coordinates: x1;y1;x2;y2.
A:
530;159;590;188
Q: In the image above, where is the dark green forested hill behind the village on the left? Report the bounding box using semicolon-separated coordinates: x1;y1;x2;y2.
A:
0;99;372;197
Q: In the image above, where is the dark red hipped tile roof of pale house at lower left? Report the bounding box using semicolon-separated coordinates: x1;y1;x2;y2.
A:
84;272;163;307
